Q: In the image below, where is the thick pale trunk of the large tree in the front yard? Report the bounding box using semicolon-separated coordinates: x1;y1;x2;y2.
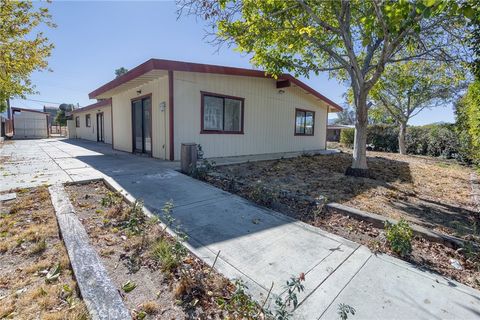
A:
346;90;369;177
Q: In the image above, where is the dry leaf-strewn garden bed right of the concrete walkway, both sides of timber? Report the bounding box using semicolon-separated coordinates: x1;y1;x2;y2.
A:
200;152;480;289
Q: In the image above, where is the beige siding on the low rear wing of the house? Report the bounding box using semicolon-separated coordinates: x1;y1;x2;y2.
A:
71;106;112;144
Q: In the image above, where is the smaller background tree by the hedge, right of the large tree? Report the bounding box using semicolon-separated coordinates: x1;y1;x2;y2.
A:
370;61;465;154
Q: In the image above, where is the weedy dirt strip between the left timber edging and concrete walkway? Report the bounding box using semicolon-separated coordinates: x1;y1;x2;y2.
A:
66;182;258;319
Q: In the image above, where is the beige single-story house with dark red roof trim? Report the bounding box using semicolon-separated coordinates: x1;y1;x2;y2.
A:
86;59;342;160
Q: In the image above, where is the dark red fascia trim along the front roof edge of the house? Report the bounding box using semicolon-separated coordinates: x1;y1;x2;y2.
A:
88;59;343;111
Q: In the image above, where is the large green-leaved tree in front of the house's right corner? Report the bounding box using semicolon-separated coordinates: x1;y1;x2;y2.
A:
179;0;472;176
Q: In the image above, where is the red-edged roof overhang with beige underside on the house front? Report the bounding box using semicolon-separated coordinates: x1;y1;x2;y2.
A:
88;59;343;111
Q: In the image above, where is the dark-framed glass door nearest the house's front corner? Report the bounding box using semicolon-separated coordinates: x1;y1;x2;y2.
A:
132;97;152;155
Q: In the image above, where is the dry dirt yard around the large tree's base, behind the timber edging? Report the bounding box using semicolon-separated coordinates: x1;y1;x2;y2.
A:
207;152;480;239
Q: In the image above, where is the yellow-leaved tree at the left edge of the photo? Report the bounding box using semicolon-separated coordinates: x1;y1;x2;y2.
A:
0;0;55;111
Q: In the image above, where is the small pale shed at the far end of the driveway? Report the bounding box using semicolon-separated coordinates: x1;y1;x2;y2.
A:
12;107;49;139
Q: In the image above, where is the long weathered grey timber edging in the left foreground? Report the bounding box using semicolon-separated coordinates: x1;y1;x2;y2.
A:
48;184;131;320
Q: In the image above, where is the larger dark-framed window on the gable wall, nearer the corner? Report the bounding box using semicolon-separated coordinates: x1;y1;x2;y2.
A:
201;92;244;134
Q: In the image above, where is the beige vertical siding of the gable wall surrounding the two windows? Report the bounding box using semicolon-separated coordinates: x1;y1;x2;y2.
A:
174;72;327;160
